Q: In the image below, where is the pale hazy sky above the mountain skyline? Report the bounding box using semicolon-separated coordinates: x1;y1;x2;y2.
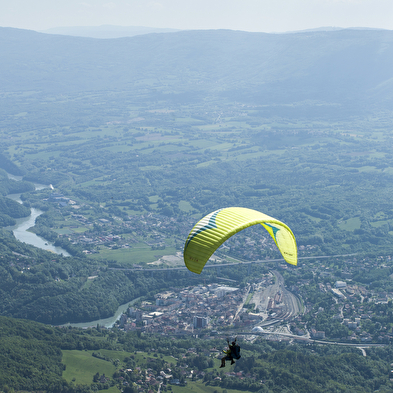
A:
0;0;393;32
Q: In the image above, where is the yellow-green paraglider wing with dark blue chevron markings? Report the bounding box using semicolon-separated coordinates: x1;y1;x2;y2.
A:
184;207;297;274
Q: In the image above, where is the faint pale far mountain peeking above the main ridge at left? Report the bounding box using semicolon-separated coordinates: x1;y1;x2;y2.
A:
40;25;180;38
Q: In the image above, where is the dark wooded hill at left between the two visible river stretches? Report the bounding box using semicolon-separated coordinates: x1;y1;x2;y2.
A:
0;231;207;325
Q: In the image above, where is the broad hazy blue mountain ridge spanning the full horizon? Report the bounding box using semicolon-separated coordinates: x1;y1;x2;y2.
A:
0;28;393;111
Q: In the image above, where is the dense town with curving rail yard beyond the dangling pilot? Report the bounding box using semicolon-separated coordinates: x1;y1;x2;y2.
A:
111;262;393;343
